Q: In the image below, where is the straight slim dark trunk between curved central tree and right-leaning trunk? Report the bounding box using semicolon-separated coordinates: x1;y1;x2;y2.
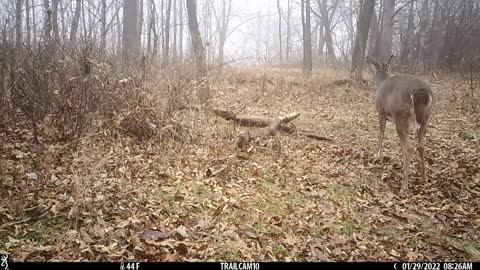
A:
302;0;312;78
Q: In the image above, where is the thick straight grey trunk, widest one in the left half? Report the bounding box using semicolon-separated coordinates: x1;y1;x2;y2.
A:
122;0;138;61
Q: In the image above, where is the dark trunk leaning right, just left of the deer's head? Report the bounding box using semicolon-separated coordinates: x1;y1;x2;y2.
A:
350;0;375;82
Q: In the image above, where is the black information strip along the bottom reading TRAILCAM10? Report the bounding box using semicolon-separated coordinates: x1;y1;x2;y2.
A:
4;261;480;270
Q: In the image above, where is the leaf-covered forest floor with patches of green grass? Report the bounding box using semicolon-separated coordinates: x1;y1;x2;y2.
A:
0;68;480;261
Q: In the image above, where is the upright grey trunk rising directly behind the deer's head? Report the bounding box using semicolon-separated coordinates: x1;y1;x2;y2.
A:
380;0;395;63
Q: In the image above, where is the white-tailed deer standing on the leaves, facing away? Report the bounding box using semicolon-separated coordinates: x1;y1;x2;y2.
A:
367;55;433;192
